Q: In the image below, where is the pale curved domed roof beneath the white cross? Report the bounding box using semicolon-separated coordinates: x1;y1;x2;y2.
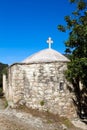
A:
22;49;69;63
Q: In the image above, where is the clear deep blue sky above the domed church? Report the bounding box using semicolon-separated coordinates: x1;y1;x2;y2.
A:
0;0;73;64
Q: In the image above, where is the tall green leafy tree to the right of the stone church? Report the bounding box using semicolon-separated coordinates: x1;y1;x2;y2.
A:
58;0;87;118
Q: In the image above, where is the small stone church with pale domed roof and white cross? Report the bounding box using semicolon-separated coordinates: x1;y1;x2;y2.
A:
3;38;74;116
